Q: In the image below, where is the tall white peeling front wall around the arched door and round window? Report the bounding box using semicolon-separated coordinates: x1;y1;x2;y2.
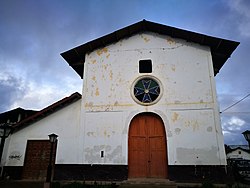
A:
82;32;226;165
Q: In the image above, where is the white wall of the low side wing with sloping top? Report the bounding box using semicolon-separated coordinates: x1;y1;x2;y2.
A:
2;100;82;166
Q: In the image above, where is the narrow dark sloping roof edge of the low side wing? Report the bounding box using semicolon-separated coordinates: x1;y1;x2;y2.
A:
12;92;82;132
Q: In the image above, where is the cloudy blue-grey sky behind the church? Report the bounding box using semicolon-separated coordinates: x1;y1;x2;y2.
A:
0;0;250;144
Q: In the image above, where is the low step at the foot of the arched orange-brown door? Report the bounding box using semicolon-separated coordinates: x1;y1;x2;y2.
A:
119;178;177;188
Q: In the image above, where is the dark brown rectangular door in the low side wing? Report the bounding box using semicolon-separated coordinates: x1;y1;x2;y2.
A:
23;140;56;180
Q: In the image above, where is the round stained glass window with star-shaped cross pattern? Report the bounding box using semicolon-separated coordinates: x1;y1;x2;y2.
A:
133;77;161;105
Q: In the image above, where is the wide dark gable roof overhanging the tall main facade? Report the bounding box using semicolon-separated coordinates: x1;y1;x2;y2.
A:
61;20;240;78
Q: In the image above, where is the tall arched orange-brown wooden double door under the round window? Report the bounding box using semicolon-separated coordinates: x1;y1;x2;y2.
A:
128;113;167;178
